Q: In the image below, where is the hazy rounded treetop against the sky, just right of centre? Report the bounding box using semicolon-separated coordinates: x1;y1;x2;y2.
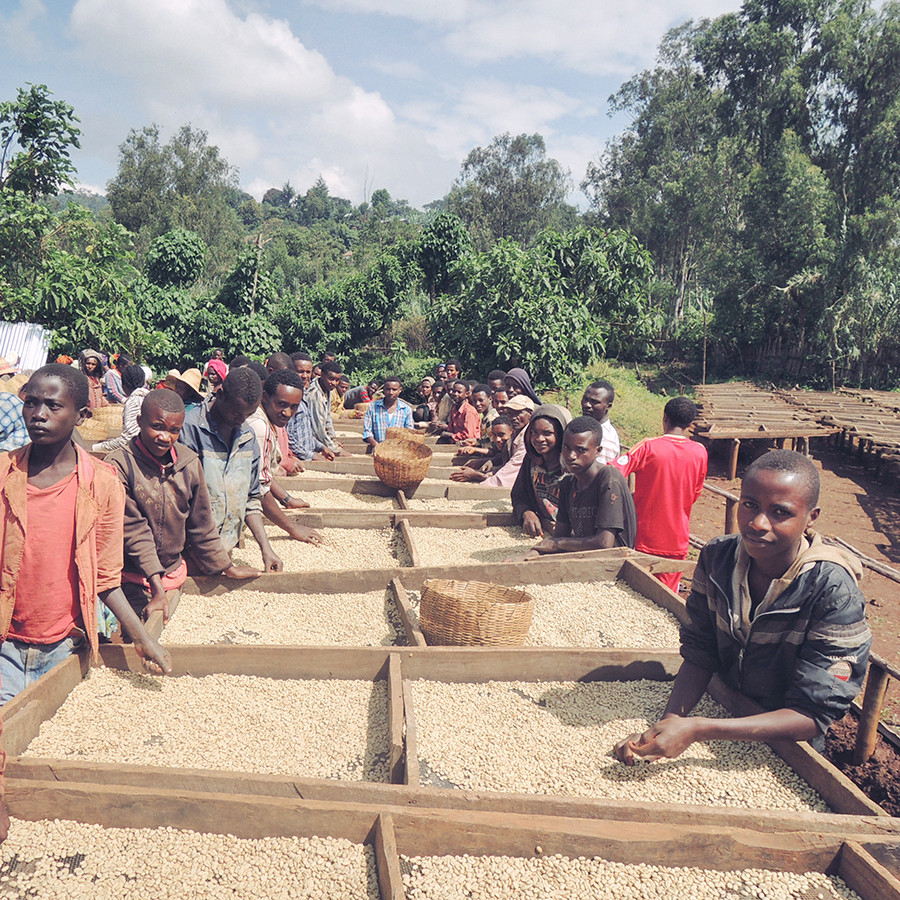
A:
447;132;570;250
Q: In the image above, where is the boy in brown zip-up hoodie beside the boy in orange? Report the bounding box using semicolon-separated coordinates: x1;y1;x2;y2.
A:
106;390;261;622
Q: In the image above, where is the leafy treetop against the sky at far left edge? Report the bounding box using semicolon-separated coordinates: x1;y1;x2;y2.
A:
0;84;81;200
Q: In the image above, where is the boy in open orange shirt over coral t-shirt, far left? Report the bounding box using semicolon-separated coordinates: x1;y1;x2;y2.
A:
0;364;172;716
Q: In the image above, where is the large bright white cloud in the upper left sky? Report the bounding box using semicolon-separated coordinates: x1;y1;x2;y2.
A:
71;0;452;203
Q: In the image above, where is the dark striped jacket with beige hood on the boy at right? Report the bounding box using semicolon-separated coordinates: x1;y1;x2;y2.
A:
681;532;872;734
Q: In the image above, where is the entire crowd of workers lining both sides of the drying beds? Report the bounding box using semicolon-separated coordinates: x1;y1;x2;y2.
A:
0;351;871;830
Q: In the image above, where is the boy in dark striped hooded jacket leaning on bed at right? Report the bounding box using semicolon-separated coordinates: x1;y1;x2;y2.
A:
615;450;872;765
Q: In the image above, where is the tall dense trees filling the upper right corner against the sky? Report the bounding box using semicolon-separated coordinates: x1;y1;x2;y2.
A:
582;0;900;383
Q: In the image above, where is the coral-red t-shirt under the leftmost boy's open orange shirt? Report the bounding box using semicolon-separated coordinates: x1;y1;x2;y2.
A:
9;470;82;644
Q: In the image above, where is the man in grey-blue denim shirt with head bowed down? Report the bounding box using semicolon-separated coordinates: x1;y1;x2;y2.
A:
181;366;284;572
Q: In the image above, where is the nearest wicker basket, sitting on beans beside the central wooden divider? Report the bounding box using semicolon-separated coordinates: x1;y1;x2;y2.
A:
419;578;534;647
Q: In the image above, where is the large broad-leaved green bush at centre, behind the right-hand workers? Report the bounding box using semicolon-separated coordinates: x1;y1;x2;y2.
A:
429;228;650;384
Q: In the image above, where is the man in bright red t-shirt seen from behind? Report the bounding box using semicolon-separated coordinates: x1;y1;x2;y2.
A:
609;397;707;593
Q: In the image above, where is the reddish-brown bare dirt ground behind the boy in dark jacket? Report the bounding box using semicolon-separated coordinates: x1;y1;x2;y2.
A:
682;439;900;724
